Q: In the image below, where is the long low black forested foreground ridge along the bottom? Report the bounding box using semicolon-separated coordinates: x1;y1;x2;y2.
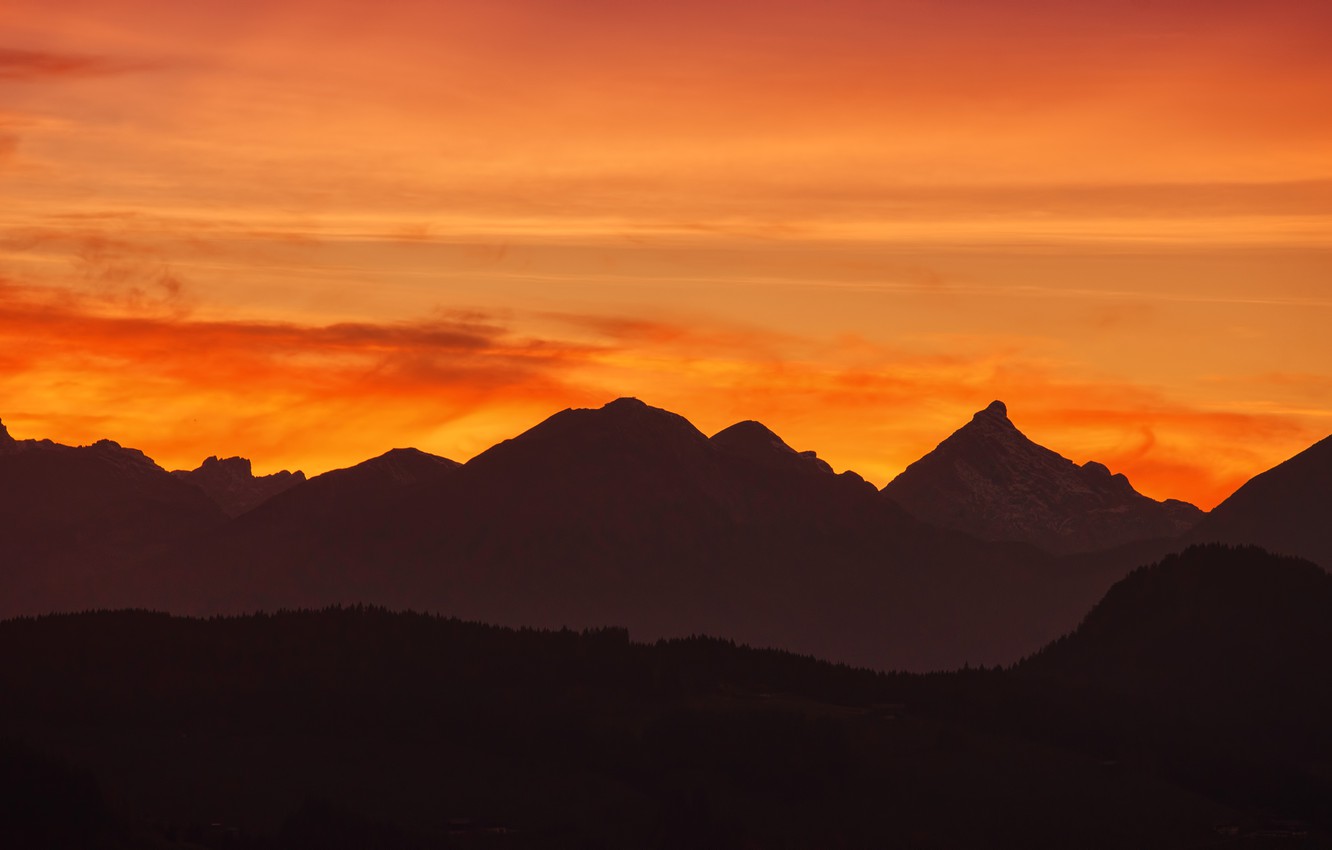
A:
10;591;1328;850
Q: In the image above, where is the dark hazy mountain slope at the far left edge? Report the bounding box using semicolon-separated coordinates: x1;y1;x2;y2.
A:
0;425;226;614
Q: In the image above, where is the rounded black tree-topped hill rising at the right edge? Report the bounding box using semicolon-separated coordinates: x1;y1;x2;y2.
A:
1018;545;1332;818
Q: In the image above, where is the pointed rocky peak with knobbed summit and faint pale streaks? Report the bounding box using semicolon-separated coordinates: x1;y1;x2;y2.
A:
883;401;1203;554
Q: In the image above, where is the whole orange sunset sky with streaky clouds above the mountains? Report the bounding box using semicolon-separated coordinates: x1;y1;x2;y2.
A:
0;0;1332;508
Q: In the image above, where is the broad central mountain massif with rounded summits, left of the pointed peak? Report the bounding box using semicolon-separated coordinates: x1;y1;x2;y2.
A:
108;398;1122;669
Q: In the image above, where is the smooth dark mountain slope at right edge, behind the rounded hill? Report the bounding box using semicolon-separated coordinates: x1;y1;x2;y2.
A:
1191;437;1332;569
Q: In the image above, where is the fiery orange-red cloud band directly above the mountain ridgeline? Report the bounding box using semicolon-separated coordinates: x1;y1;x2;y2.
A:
0;281;1325;506
